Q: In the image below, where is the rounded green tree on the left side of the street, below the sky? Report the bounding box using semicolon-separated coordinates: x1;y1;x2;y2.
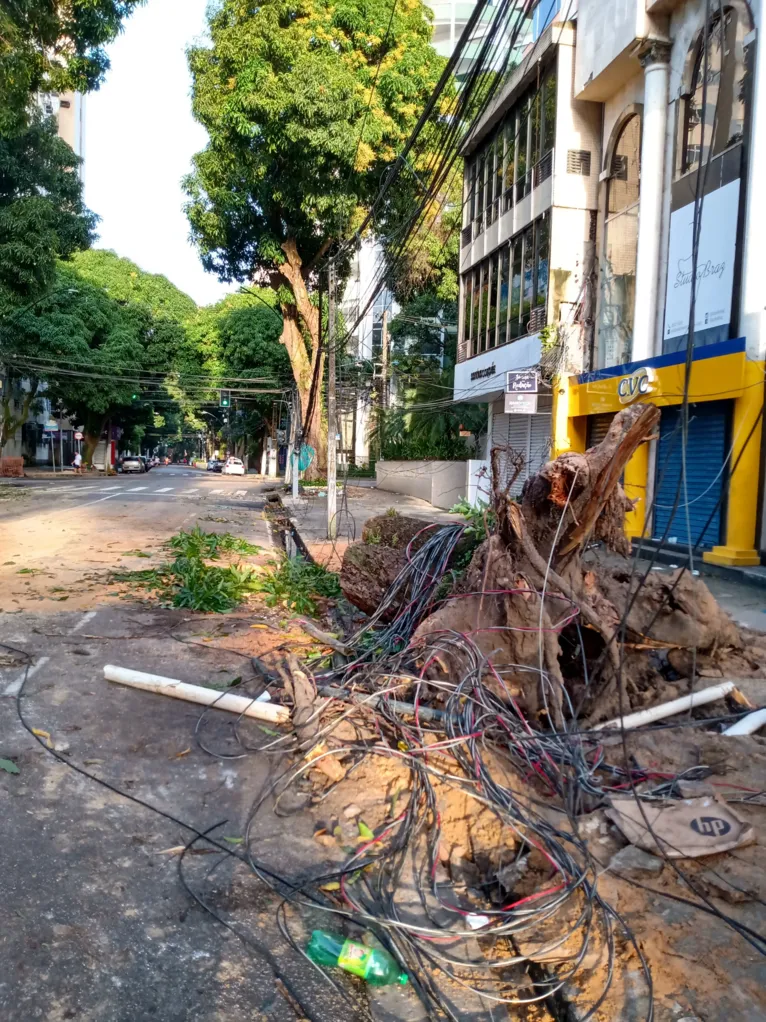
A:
8;250;196;460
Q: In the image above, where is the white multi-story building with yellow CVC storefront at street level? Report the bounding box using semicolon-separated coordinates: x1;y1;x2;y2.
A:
454;0;766;564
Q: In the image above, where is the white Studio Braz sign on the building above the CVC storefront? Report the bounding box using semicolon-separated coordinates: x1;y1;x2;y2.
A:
665;180;739;339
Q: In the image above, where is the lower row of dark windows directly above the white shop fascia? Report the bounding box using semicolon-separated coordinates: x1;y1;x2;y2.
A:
461;213;550;358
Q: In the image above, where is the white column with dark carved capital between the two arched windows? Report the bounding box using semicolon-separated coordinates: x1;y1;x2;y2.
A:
631;42;670;362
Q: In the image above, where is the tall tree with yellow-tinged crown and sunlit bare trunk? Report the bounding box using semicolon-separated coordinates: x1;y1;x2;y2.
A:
186;0;444;468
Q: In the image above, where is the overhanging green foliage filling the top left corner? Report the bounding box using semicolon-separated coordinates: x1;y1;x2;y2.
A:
0;0;143;132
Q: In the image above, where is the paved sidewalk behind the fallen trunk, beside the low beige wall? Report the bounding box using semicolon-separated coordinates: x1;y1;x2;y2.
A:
281;480;463;571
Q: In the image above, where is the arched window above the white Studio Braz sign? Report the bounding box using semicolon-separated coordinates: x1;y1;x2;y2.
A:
678;6;750;174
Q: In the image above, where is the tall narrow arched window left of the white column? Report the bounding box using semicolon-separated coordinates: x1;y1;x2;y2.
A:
599;113;641;368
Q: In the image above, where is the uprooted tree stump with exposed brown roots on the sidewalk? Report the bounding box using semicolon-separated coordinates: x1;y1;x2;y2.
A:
341;405;739;722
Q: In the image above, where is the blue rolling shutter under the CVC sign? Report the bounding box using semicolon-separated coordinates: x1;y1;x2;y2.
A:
654;401;731;548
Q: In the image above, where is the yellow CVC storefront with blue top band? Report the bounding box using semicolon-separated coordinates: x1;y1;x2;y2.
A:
554;338;764;565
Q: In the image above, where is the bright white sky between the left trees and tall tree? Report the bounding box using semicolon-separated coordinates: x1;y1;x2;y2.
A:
84;0;236;305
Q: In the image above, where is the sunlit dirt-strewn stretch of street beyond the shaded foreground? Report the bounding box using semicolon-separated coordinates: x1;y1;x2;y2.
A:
0;466;271;612
